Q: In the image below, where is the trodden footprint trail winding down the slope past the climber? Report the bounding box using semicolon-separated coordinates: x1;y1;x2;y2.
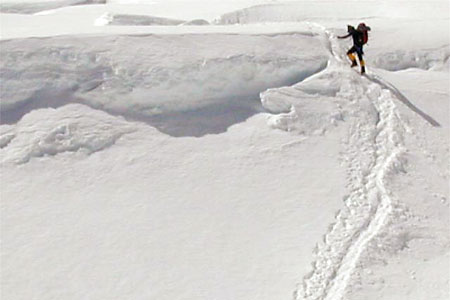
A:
295;24;405;300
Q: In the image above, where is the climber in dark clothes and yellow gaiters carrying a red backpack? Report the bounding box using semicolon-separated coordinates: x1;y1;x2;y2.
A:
338;23;370;74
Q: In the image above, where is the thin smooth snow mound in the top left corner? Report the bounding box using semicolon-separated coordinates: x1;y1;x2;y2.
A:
0;0;106;14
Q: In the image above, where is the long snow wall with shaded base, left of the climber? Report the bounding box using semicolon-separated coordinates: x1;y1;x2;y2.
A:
0;34;327;135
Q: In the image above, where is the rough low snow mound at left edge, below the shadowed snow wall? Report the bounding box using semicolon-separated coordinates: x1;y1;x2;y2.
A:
0;104;135;164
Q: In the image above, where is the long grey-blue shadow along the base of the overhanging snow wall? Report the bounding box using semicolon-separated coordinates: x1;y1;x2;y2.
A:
0;71;316;137
